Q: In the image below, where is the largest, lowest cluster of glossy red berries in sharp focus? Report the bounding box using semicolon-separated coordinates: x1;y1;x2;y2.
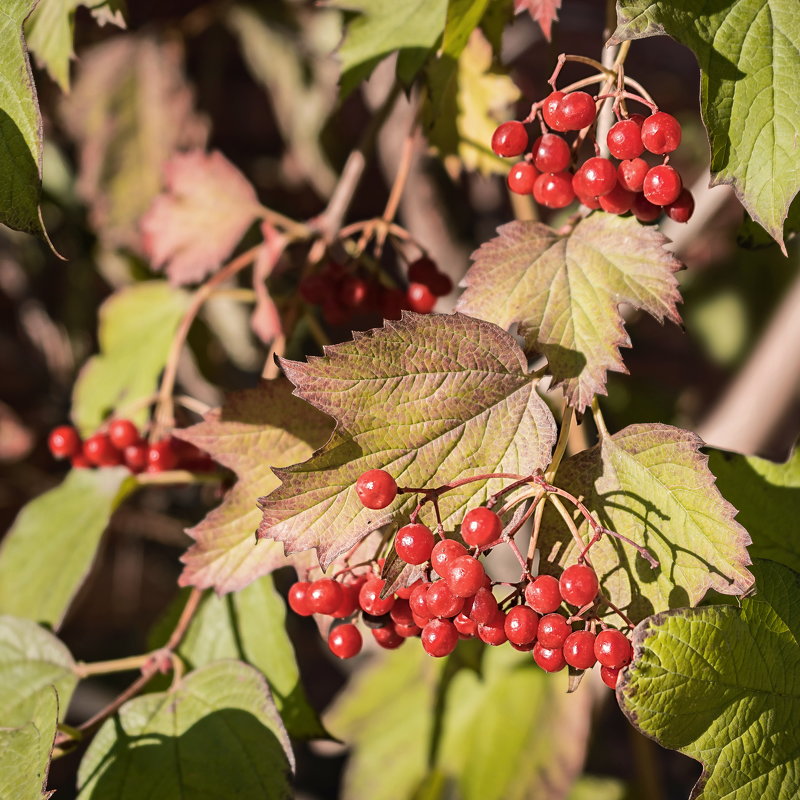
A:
289;470;632;688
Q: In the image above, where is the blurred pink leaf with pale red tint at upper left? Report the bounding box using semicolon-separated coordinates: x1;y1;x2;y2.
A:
141;150;259;285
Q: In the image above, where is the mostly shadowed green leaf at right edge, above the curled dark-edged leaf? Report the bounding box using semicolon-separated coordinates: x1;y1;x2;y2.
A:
709;450;800;572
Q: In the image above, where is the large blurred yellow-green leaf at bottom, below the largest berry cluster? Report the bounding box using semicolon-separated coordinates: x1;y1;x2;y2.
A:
326;643;592;800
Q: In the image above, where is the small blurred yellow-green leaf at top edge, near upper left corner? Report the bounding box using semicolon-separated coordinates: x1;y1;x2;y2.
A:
25;0;125;92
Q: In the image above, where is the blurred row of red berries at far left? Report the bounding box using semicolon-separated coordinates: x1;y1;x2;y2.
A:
47;419;216;474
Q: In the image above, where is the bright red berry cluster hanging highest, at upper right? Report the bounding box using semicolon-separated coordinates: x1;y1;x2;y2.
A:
492;91;694;227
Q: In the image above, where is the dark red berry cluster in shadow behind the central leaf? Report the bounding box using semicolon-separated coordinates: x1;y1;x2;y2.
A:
299;256;453;325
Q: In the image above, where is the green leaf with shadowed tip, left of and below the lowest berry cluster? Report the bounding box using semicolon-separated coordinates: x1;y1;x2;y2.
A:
153;576;328;739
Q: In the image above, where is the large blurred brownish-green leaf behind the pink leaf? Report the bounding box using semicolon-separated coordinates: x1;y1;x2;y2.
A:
62;34;208;250
